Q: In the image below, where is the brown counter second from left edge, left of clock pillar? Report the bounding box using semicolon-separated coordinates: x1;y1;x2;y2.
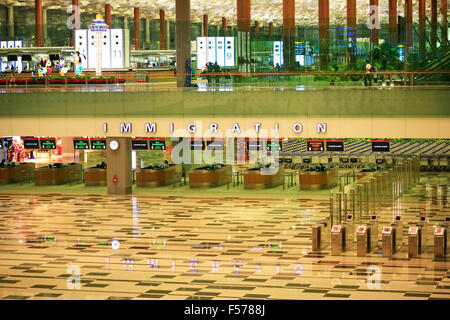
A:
34;163;83;186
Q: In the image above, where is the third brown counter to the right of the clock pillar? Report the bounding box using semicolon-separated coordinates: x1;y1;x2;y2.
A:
244;167;284;189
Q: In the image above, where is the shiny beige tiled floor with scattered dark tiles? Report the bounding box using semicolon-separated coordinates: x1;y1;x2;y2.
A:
0;178;450;300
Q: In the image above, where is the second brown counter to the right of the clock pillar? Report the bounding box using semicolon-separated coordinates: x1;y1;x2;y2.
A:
189;165;231;188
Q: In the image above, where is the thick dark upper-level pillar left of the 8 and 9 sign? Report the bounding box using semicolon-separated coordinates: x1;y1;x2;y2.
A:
175;0;191;87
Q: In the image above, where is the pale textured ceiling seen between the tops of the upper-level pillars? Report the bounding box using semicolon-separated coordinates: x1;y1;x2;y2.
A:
0;0;430;25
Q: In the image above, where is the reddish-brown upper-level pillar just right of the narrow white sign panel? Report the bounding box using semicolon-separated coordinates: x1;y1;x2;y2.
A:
283;0;296;71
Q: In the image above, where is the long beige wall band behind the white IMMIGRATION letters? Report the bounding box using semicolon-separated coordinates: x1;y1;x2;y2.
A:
0;117;450;138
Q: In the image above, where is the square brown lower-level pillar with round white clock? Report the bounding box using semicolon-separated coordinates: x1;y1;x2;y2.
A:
106;137;133;195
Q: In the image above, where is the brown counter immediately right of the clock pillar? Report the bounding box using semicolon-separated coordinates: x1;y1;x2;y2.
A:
136;164;182;187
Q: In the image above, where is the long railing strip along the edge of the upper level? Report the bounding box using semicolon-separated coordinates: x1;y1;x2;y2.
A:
0;71;450;91
